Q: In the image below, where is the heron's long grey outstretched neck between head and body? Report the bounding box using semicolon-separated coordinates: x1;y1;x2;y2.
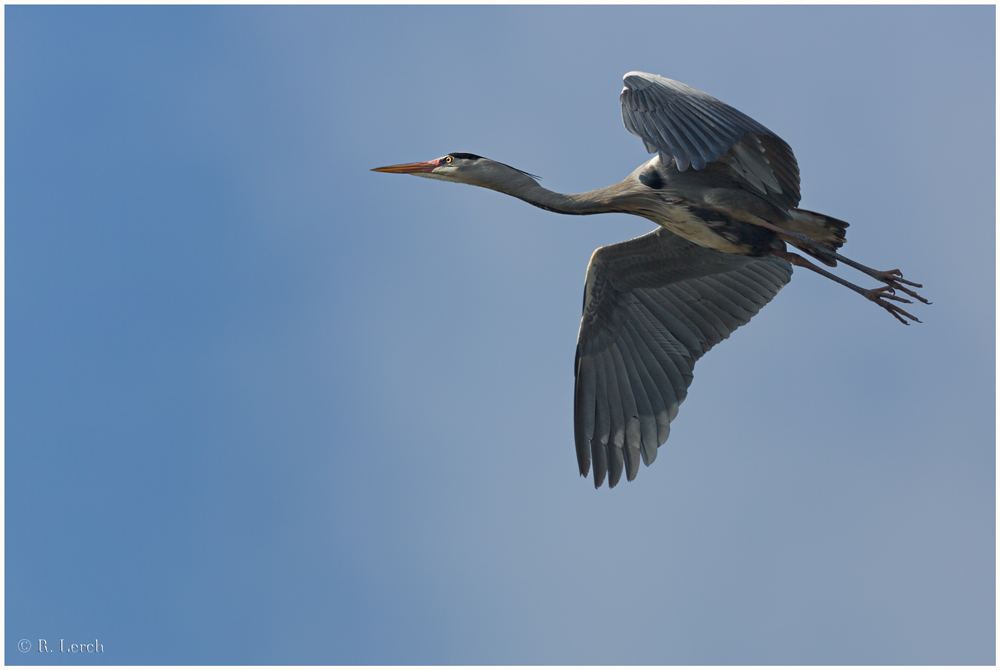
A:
469;165;626;214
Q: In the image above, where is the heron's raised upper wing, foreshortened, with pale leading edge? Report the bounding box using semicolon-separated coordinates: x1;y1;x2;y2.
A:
621;72;800;209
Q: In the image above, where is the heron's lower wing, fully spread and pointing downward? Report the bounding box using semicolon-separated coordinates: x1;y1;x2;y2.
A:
573;228;792;487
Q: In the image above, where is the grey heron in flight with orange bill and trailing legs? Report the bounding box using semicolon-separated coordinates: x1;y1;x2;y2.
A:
372;71;929;488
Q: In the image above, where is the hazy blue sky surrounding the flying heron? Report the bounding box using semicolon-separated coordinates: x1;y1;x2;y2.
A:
4;6;996;664
